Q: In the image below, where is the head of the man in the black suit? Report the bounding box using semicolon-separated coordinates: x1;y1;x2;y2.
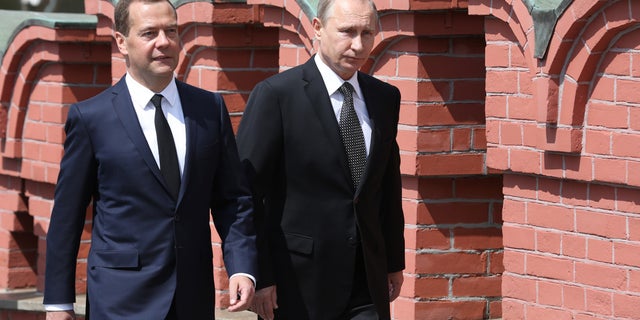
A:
313;0;376;79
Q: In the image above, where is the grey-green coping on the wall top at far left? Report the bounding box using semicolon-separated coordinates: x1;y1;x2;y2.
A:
0;10;98;61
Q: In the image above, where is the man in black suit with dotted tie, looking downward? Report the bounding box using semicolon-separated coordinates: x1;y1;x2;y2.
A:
237;0;404;320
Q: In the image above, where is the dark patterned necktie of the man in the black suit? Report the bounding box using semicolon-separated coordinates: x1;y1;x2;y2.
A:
338;82;367;189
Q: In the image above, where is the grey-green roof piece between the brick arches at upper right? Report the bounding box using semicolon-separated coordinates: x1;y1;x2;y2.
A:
522;0;573;59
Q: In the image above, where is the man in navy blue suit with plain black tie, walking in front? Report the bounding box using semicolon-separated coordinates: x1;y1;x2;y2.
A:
44;0;257;320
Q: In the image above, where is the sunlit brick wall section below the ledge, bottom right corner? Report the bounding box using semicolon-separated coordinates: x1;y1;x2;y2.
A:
503;175;640;319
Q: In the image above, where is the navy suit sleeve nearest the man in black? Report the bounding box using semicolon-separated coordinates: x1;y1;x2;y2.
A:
211;95;257;277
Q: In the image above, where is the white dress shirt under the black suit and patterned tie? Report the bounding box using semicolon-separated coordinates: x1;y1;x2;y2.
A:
314;54;371;156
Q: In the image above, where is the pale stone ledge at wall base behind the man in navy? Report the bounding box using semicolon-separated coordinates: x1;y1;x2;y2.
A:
0;289;257;320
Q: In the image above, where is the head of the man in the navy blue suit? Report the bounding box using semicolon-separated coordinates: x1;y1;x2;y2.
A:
116;2;180;92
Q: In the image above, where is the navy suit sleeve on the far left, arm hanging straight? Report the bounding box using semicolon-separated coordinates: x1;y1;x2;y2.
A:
44;105;97;304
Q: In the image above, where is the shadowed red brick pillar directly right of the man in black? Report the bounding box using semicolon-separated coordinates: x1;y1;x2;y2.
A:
384;25;502;320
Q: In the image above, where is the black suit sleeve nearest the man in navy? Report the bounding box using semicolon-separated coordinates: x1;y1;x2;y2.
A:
237;82;282;288
